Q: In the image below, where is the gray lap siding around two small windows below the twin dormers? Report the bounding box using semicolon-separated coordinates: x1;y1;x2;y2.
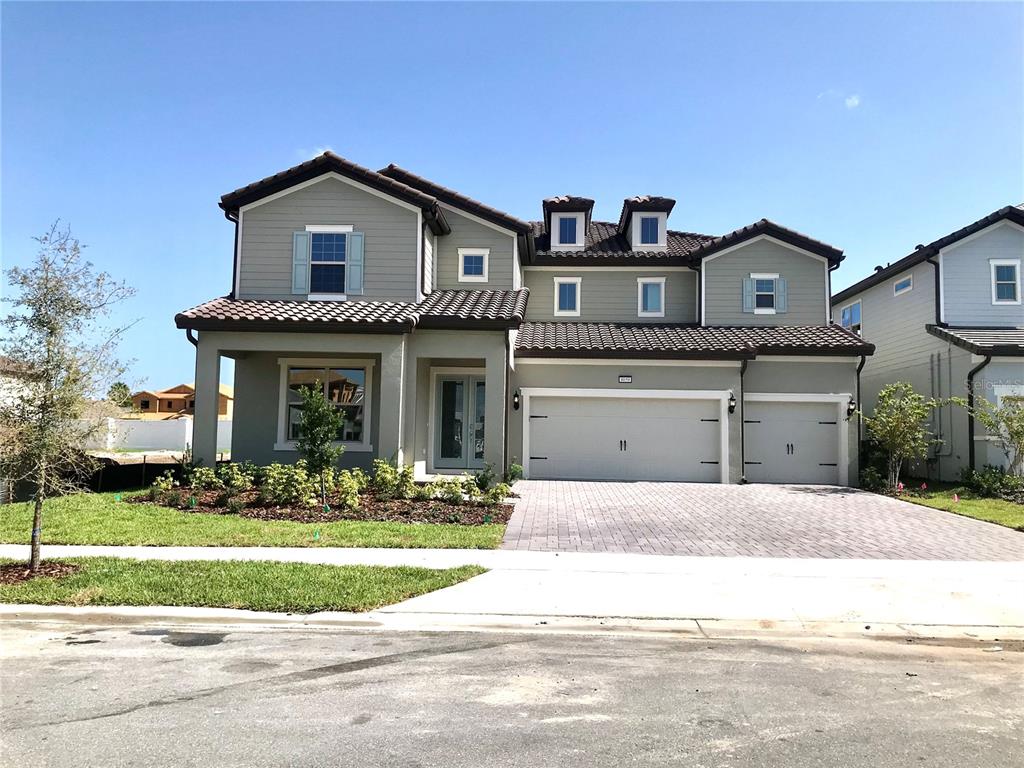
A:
525;268;697;323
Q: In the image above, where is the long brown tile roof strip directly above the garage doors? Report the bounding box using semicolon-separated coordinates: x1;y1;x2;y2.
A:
516;323;874;359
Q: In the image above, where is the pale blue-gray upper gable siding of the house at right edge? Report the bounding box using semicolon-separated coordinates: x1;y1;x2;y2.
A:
942;223;1024;327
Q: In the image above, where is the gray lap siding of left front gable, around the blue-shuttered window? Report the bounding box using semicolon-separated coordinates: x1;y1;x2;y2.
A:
239;178;417;301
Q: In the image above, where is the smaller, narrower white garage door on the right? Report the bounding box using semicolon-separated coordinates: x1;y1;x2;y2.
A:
743;401;840;485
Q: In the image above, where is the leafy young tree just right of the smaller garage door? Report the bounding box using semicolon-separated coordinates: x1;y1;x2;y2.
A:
862;381;949;490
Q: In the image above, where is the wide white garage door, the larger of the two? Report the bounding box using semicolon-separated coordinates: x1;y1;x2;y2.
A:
528;397;721;482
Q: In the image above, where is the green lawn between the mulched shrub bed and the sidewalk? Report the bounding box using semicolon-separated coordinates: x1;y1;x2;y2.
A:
0;494;505;549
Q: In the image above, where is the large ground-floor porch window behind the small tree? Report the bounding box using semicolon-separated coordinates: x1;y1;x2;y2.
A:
276;360;373;450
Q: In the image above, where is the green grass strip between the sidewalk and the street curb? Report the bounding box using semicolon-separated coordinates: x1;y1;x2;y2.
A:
0;557;484;613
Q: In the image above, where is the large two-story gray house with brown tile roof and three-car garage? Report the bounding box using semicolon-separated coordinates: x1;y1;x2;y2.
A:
175;153;872;484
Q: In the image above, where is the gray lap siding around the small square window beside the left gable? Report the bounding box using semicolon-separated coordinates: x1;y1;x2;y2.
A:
434;210;515;291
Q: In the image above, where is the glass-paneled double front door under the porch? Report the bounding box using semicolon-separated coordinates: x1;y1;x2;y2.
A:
434;376;486;469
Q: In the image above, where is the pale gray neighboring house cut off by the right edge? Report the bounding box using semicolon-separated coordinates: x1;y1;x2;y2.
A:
833;206;1024;480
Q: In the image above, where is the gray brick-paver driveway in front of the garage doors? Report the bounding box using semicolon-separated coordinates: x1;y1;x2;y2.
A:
502;480;1024;560
